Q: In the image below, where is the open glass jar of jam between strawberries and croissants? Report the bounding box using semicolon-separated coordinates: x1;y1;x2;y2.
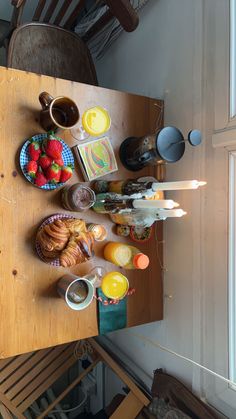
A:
62;183;96;212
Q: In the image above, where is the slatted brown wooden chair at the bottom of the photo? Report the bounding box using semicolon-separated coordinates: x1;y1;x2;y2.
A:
0;338;150;419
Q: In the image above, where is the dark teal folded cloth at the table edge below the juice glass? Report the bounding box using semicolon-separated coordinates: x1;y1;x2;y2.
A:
97;288;127;335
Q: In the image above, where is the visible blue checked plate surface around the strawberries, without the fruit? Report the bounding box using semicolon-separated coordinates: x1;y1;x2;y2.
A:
20;133;74;191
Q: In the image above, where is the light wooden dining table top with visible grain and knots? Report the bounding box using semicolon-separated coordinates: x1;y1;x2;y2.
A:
0;67;163;358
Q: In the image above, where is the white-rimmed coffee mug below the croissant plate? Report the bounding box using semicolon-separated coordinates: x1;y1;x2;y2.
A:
57;274;97;310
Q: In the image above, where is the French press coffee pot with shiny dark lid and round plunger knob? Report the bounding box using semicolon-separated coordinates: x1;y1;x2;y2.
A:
119;127;202;172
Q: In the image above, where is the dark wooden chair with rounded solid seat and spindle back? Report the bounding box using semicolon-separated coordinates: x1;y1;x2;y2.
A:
4;0;138;85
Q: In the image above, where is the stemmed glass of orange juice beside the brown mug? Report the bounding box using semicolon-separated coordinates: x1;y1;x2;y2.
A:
71;106;111;141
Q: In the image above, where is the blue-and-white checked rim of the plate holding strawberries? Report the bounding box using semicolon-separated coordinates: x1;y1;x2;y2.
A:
19;133;75;191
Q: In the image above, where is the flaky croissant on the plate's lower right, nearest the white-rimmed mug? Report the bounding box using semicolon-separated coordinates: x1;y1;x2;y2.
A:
59;232;94;267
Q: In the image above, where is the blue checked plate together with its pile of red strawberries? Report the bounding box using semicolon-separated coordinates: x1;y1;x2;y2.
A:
20;133;74;190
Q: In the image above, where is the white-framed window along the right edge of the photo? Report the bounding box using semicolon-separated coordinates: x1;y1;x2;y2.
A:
204;0;236;419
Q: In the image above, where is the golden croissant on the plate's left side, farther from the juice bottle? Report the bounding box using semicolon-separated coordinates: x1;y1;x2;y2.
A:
36;220;70;252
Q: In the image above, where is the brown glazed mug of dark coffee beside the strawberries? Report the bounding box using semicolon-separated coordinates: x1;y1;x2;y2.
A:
39;92;79;132
